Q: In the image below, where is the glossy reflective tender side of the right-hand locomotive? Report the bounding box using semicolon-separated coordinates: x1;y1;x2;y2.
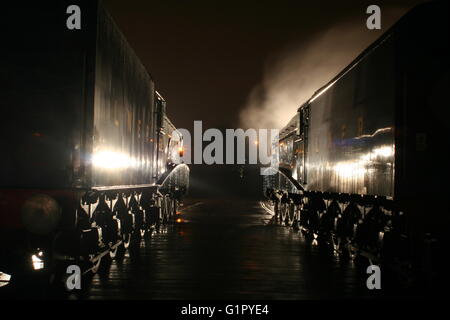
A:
306;36;396;197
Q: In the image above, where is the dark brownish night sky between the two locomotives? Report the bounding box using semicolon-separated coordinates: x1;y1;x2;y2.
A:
104;0;420;129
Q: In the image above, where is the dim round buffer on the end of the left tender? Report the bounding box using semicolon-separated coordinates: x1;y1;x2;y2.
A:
22;194;61;235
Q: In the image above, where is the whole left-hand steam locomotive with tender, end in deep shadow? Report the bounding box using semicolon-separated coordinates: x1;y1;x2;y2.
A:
0;0;189;279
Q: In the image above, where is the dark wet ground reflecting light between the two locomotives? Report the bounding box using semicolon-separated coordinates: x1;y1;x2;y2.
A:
79;199;378;299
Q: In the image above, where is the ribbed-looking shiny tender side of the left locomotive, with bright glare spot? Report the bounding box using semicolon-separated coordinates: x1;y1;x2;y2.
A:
91;4;156;187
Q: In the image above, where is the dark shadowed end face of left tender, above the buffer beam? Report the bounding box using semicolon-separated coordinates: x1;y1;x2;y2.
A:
0;1;96;188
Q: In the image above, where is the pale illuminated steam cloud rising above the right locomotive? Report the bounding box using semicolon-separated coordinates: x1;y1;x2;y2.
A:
240;8;405;128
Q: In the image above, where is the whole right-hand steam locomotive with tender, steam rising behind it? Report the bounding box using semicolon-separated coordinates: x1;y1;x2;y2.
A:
264;2;450;281
